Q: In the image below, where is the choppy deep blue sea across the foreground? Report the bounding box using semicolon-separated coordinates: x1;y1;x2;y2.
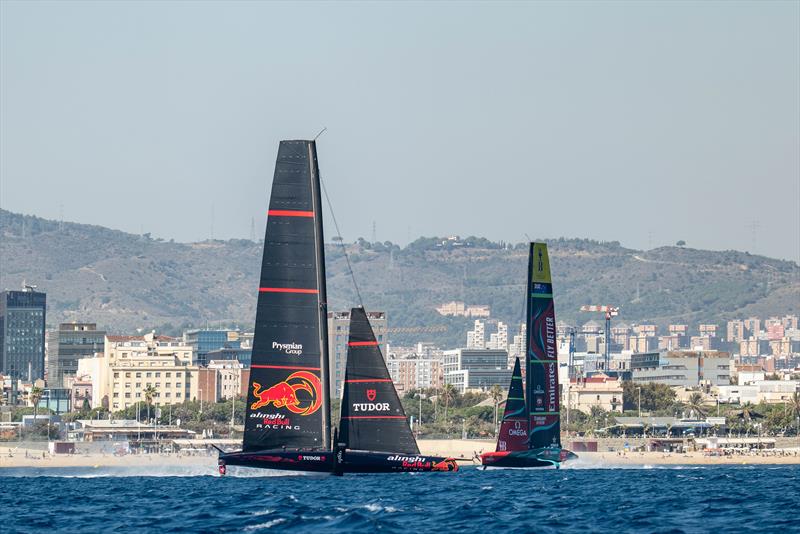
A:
0;466;800;534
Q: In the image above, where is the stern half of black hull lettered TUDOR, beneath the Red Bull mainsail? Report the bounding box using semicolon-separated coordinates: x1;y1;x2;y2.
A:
218;450;334;475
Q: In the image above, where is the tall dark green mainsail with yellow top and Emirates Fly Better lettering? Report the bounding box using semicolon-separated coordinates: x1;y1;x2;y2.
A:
525;243;561;449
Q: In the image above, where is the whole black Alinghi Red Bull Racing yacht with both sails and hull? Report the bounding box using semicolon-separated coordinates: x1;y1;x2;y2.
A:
218;141;455;474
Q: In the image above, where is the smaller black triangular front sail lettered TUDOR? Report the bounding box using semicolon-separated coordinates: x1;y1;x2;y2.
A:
339;308;419;454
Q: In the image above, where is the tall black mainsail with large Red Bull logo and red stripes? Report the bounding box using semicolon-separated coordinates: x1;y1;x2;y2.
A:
243;141;331;451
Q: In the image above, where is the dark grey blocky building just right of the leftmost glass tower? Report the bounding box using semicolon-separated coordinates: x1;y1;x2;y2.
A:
47;323;106;388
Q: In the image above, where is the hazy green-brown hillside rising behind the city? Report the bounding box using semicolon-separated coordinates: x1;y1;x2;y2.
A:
0;210;800;346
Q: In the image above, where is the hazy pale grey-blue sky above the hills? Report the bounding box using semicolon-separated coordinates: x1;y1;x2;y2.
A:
0;1;800;260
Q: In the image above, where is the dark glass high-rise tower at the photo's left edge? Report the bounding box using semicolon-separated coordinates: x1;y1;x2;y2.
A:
0;286;47;381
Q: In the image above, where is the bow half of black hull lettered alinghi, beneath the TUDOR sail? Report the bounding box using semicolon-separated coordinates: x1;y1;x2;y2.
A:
338;450;458;473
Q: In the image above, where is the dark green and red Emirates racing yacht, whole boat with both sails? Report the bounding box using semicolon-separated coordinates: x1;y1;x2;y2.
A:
480;243;578;468
